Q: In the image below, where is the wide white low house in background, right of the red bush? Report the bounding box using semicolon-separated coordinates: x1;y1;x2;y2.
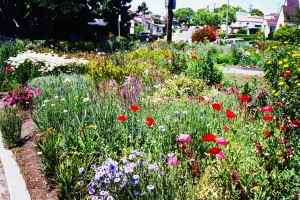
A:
229;12;264;35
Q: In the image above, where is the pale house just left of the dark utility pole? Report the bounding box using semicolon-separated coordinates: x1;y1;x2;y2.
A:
133;14;165;34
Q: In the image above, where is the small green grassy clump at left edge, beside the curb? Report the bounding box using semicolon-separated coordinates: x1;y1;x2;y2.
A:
0;107;23;148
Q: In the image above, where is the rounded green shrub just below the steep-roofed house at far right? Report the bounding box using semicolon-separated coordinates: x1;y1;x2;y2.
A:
273;24;300;43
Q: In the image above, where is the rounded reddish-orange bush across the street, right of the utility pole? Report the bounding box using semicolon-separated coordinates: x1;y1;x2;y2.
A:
192;26;217;42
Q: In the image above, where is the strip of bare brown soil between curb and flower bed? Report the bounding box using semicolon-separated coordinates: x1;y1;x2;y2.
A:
0;93;58;200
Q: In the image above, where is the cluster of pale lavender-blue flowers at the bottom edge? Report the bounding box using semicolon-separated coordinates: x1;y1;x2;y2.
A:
79;150;159;200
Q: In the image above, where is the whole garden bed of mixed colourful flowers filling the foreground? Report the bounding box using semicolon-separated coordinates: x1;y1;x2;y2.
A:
0;36;300;200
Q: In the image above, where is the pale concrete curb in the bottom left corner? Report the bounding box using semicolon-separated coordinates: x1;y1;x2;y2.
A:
0;132;31;200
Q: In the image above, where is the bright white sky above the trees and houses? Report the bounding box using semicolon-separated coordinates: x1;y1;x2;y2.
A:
131;0;285;15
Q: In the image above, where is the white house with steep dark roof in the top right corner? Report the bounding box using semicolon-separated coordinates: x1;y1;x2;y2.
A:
276;0;300;30
